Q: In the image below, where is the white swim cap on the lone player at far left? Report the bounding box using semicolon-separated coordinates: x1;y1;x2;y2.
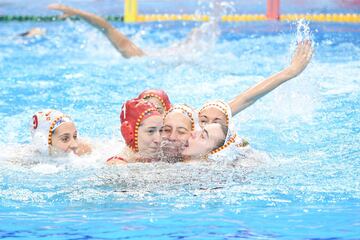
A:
30;109;73;154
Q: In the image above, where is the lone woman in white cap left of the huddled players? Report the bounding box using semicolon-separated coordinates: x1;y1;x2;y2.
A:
31;109;91;156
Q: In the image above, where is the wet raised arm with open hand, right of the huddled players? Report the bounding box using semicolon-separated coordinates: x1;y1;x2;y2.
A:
229;40;313;116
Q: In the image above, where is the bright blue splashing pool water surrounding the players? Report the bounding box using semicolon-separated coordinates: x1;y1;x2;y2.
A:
0;17;360;239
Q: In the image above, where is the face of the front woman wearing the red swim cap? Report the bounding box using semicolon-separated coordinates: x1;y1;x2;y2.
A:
138;116;163;156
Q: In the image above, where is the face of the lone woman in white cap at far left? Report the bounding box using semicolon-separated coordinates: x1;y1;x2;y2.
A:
51;122;78;154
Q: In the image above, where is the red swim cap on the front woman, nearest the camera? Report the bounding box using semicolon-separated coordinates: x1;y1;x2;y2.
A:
120;98;161;152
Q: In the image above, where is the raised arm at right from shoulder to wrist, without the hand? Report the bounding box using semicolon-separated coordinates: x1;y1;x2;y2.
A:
229;68;293;116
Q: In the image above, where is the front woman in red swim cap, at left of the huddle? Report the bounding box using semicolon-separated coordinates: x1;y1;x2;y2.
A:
107;99;163;165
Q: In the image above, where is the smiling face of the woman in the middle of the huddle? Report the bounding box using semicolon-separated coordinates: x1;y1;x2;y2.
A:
162;110;192;155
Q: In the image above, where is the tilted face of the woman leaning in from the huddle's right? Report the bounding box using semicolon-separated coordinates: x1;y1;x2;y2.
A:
182;123;225;158
